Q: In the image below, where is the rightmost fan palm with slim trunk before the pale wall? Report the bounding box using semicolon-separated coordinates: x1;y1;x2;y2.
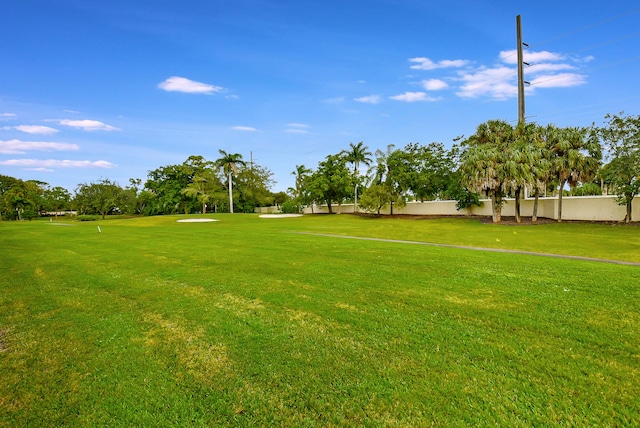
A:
548;125;602;222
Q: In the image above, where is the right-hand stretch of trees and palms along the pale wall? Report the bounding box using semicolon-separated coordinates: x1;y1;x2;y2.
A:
292;113;640;223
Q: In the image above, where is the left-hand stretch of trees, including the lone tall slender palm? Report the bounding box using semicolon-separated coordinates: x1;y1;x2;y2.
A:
0;150;287;220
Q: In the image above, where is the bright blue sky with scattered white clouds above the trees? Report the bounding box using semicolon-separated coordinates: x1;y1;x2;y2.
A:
0;0;640;191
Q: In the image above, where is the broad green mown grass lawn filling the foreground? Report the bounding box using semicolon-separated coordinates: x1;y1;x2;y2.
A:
0;214;640;427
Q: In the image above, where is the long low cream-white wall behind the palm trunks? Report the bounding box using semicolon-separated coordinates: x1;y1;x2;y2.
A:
304;196;640;221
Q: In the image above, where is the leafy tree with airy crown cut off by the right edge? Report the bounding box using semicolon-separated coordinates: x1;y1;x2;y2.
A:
599;112;640;223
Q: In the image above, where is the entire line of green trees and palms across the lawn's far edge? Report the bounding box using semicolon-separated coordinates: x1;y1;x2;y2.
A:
0;113;640;222
